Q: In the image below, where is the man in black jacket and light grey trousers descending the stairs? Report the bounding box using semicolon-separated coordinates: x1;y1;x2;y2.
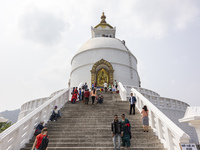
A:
111;115;123;150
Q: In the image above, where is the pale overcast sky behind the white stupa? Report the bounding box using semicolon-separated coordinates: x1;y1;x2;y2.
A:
0;0;200;111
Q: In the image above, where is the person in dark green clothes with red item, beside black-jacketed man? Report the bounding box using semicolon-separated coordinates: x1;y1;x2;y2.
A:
120;114;131;149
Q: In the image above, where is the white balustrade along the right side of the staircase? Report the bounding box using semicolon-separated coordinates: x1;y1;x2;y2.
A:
131;88;190;150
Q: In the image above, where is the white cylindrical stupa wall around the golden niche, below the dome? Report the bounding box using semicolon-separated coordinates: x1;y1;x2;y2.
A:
70;48;139;87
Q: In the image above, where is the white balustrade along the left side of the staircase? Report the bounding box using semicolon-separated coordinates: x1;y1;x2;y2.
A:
0;89;70;150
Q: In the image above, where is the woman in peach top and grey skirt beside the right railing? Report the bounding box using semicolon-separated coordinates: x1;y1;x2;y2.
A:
141;105;149;132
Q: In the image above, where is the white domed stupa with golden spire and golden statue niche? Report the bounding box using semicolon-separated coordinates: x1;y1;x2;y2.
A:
69;13;140;87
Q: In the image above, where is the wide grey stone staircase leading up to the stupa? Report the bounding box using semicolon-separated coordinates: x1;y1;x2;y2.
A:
21;92;164;150
